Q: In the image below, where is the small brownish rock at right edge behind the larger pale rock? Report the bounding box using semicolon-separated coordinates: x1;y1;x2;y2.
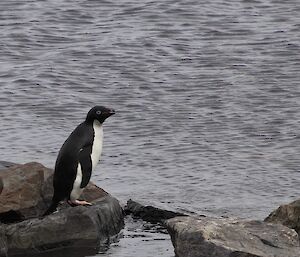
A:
265;199;300;235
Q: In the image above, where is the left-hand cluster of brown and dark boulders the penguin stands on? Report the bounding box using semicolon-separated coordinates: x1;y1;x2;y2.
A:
0;163;124;257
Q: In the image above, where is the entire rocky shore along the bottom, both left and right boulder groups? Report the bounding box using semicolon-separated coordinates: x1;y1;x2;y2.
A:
0;162;300;257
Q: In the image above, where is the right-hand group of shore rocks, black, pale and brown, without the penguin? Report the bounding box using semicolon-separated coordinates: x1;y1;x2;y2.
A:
125;200;300;257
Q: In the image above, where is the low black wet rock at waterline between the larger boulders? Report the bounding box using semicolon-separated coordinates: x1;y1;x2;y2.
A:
124;199;186;223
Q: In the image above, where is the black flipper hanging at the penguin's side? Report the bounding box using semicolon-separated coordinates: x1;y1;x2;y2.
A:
79;145;93;188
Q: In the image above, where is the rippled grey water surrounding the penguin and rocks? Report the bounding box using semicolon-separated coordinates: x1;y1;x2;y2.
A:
0;0;300;257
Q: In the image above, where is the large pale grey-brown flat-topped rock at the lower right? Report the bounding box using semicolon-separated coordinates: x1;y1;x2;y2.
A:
165;217;300;257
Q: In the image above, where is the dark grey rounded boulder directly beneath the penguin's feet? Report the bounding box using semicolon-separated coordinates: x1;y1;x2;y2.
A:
5;195;123;256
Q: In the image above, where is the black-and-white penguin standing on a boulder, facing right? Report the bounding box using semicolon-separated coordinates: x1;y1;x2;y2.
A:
43;106;115;216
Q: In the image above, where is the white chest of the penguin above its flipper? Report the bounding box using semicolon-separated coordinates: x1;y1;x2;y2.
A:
91;120;103;169
